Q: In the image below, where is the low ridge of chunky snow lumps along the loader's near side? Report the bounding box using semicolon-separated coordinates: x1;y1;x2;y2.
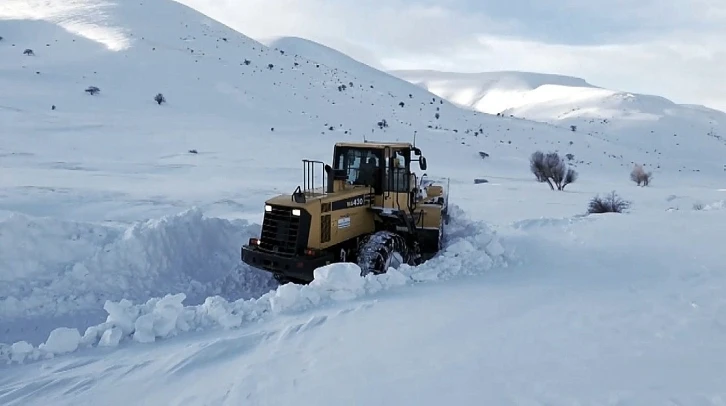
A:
0;207;509;363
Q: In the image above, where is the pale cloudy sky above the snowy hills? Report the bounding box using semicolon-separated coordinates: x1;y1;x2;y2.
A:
177;0;726;110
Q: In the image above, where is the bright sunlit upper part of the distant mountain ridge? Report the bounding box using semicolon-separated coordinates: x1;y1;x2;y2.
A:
390;70;726;120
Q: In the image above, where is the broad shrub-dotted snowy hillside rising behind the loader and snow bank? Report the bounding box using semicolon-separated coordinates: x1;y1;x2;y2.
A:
0;0;592;221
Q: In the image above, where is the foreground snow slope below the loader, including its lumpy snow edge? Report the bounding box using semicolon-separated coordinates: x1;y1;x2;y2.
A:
0;188;726;405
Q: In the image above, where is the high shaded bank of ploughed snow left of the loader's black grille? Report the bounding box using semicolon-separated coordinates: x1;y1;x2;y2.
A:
0;209;277;321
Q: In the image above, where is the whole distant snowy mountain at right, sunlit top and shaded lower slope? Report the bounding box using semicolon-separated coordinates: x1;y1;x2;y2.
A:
391;70;726;161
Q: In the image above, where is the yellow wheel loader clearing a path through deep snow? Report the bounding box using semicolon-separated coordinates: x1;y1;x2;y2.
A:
241;142;449;284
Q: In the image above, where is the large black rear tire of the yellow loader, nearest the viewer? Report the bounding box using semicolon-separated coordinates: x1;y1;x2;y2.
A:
357;231;412;276
